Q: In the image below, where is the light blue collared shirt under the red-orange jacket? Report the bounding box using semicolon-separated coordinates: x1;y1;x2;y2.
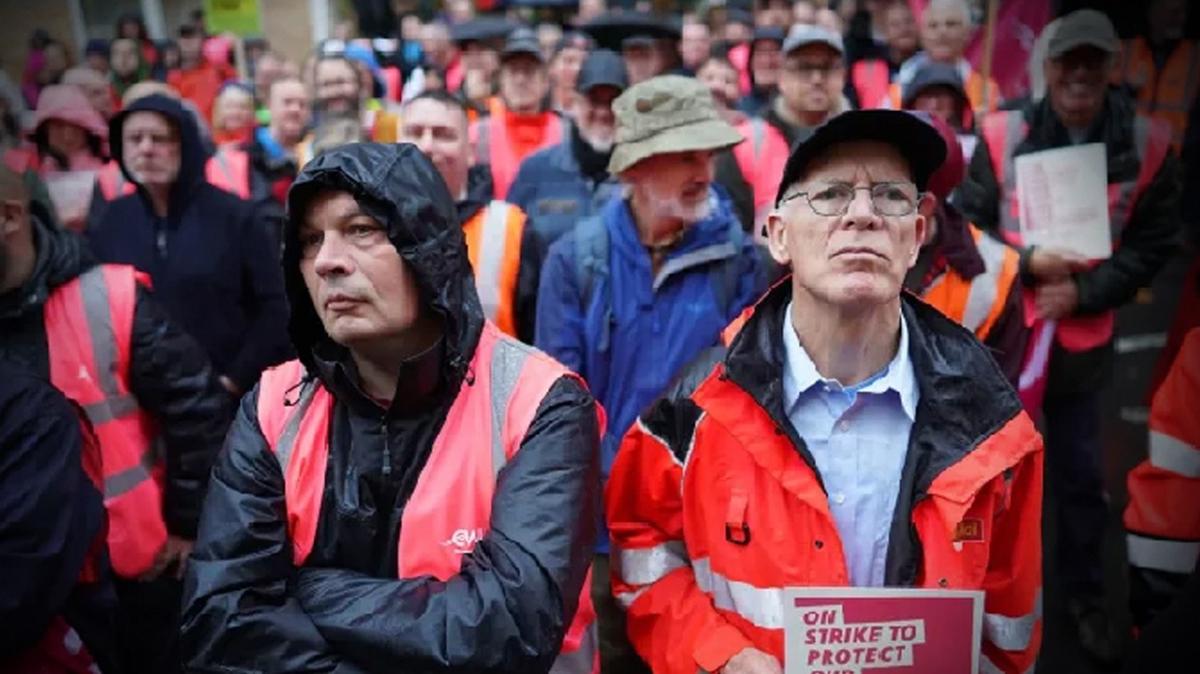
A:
784;303;920;586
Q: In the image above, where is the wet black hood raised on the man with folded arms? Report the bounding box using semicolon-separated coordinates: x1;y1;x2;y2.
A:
283;143;484;391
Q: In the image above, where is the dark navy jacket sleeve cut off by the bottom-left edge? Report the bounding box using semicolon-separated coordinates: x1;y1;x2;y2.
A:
0;368;104;652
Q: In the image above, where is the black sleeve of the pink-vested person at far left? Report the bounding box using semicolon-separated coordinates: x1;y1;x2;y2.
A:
130;287;233;540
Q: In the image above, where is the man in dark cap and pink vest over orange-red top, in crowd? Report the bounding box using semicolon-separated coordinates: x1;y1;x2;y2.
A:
470;28;566;199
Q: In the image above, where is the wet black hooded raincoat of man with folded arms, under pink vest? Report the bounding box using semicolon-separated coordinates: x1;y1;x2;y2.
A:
182;144;599;673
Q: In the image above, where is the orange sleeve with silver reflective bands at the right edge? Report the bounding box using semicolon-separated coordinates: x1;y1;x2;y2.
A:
1124;329;1200;574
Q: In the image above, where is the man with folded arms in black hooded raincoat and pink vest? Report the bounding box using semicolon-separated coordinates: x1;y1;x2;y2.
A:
182;144;600;674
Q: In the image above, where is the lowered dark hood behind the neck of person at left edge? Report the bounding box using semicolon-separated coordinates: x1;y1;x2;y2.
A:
0;216;96;318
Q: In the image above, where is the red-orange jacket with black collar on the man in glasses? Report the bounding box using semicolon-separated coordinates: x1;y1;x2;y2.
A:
606;285;1042;674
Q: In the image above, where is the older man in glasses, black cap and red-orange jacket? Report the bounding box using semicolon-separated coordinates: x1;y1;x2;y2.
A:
606;110;1042;674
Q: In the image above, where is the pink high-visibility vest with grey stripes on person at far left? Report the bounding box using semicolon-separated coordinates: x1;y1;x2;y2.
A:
43;265;167;578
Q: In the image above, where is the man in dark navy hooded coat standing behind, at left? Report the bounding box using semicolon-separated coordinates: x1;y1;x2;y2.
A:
88;95;288;396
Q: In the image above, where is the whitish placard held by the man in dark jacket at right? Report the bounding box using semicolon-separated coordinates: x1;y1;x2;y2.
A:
1014;143;1112;259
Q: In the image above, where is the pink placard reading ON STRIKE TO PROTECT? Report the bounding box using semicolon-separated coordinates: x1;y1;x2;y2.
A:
784;588;983;674
